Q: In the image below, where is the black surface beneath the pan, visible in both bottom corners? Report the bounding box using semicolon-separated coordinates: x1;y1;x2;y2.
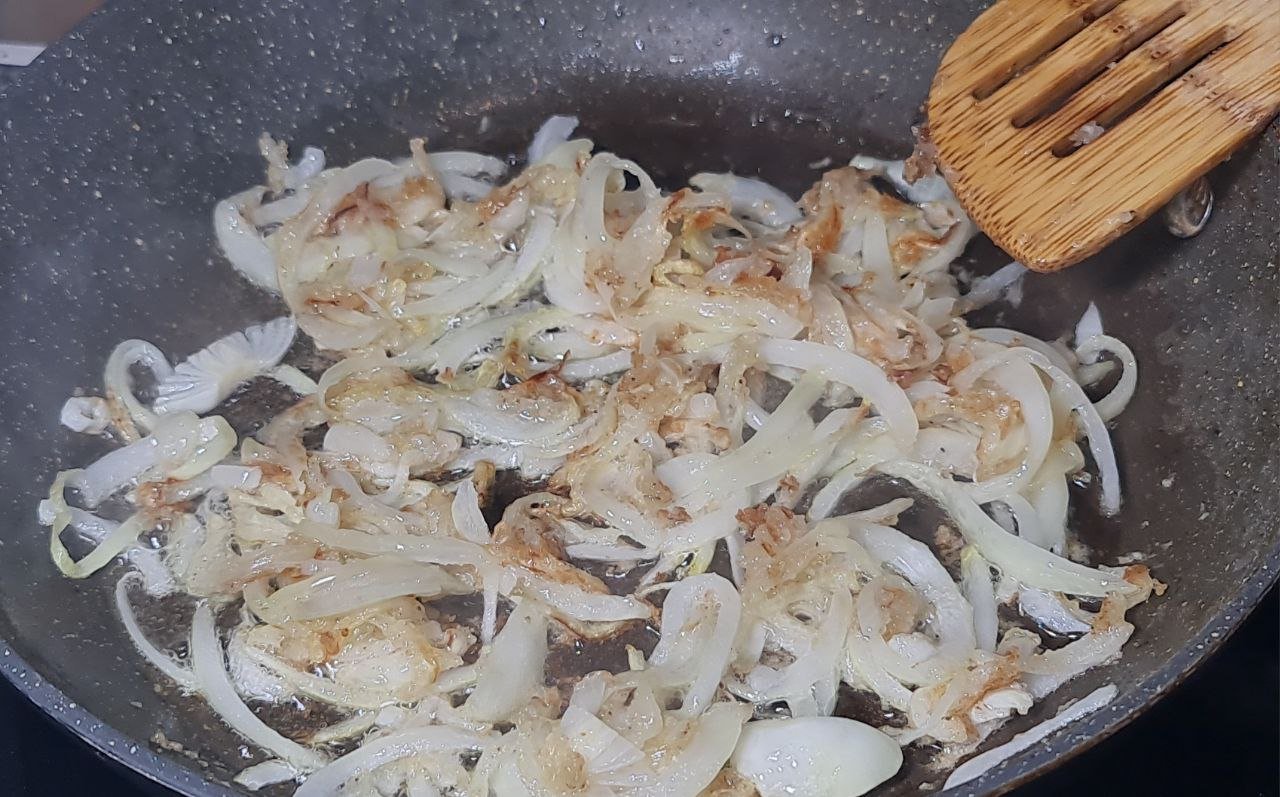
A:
0;590;1280;797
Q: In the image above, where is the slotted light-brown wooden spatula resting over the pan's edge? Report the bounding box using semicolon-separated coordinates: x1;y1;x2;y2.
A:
928;0;1280;271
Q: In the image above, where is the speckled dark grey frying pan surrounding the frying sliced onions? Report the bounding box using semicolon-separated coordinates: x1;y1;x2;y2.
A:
0;0;1280;796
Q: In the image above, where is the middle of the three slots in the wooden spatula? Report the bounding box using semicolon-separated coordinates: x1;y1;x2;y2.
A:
1011;4;1185;128
